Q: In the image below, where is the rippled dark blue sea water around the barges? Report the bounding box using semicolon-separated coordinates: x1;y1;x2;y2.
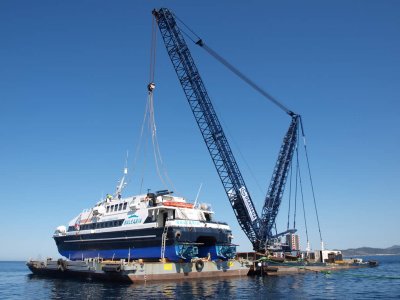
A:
0;256;400;299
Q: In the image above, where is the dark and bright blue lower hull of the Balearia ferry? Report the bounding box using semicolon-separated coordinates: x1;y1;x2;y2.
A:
54;227;232;261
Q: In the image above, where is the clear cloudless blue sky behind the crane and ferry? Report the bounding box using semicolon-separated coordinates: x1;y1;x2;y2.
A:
0;0;400;259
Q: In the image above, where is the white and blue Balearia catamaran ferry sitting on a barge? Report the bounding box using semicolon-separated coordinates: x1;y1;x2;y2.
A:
53;170;236;262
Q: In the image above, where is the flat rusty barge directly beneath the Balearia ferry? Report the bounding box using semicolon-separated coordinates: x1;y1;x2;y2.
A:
27;258;250;283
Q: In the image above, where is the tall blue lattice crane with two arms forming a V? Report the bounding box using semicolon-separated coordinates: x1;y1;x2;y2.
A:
152;8;301;251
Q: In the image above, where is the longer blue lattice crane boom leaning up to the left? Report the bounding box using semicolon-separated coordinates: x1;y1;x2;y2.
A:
153;8;260;247
